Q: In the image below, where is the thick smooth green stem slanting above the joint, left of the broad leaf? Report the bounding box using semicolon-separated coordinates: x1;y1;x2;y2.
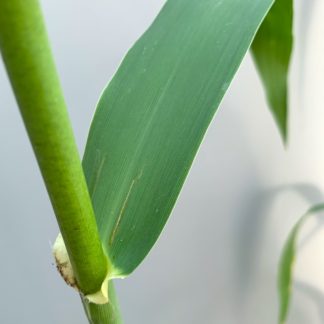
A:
0;0;107;294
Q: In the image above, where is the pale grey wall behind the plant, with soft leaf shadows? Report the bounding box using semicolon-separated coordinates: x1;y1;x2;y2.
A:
0;0;324;324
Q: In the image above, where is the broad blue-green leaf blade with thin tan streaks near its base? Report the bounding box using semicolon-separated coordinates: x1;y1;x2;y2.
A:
83;0;273;277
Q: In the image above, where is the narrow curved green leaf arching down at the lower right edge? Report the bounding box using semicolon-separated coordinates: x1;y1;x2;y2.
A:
278;204;324;324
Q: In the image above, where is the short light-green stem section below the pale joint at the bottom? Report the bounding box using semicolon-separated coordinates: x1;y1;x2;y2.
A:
81;281;122;324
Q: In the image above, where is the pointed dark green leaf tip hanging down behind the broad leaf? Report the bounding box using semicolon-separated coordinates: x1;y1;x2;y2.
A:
252;0;293;141
